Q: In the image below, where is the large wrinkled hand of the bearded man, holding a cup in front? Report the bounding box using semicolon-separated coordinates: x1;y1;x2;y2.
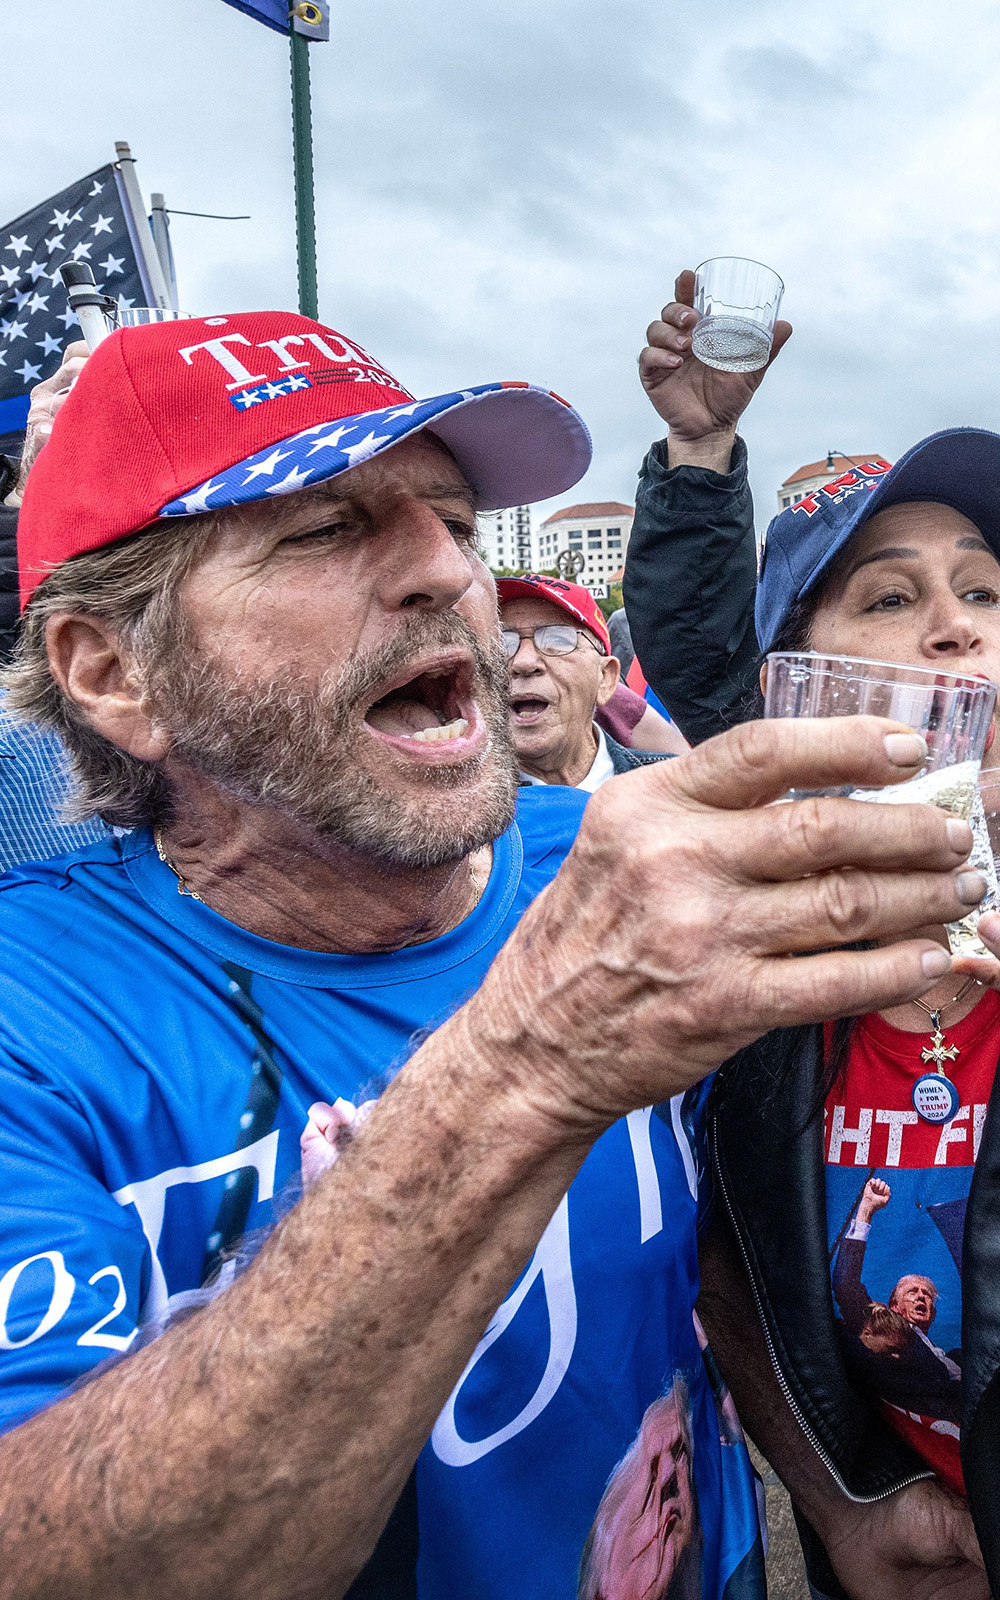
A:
466;717;984;1134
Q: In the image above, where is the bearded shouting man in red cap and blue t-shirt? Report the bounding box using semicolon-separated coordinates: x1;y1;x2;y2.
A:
0;312;976;1600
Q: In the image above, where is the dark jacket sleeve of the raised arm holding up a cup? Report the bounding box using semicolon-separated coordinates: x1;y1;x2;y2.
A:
624;438;760;744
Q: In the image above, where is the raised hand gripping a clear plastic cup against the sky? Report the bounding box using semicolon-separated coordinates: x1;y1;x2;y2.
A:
638;272;792;464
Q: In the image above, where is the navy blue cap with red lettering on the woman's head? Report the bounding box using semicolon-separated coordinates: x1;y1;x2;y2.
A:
755;427;1000;651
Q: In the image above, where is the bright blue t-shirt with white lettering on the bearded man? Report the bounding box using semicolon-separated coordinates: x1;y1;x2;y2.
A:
0;787;763;1600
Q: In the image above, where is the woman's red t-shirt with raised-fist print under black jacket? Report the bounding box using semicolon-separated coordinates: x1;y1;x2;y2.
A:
824;990;1000;1494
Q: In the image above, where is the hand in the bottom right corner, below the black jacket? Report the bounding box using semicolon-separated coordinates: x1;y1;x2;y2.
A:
824;1478;990;1600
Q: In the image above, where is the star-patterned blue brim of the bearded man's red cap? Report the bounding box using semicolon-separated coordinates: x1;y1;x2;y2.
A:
160;382;590;517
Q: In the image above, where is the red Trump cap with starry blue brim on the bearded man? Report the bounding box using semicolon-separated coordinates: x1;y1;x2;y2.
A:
18;310;590;608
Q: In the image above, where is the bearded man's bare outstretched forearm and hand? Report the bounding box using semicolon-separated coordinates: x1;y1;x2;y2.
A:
0;718;982;1600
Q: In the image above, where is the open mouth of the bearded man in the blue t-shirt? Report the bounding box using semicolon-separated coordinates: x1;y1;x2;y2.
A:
365;658;485;760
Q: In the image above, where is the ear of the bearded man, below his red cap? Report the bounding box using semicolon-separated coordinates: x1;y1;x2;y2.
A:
45;611;171;762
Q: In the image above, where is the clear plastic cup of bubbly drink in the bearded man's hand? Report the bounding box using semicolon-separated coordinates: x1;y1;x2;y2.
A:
765;651;1000;955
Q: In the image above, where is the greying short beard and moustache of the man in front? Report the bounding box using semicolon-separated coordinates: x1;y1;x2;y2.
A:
147;611;517;867
